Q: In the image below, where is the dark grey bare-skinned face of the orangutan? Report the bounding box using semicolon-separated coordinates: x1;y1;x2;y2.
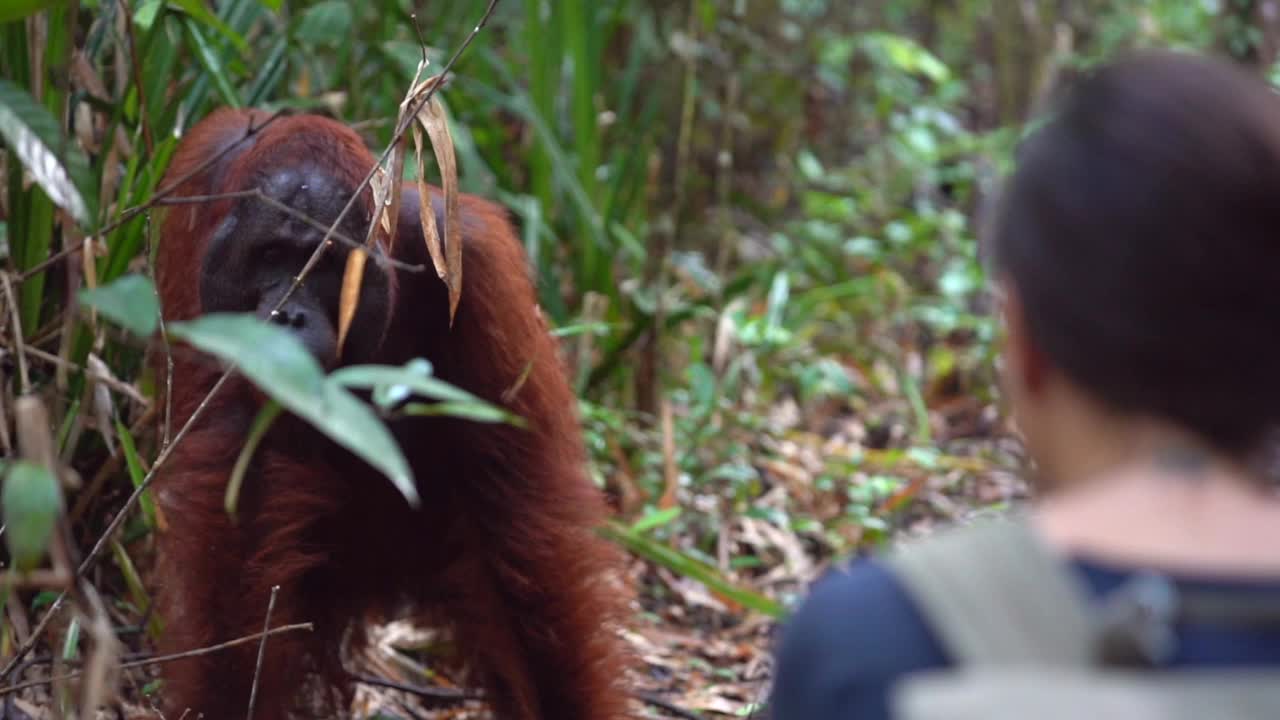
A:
200;161;390;369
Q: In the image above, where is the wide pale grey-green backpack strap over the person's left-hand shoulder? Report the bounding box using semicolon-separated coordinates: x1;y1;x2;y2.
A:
884;515;1097;666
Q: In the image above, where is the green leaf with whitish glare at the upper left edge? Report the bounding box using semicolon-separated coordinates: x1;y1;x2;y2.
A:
0;79;92;227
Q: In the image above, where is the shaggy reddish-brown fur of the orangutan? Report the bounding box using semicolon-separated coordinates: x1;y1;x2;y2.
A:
156;110;627;720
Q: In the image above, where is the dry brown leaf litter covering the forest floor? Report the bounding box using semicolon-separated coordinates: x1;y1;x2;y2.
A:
0;384;1027;720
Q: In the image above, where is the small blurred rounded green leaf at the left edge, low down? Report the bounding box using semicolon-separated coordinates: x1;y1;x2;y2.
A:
0;460;61;571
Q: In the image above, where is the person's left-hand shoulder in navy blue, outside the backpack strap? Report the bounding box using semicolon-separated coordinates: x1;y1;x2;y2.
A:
757;550;947;717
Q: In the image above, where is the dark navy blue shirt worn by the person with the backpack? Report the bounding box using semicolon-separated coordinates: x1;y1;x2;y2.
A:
771;559;1280;720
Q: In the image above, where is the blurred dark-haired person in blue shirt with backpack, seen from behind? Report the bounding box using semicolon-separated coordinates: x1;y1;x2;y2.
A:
771;51;1280;720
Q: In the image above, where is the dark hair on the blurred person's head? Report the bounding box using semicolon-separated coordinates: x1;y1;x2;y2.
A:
988;51;1280;455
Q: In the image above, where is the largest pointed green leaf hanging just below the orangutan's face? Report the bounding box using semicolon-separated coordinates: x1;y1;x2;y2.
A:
169;314;419;506
